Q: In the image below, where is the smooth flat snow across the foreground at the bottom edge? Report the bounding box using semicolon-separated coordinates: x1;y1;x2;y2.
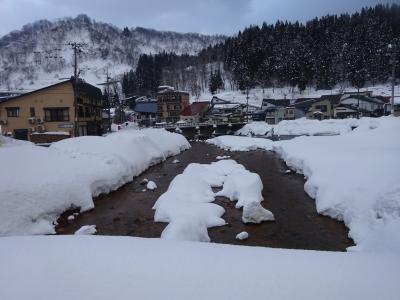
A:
0;236;400;300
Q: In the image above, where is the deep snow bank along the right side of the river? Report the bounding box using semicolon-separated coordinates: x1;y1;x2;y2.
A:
208;117;400;252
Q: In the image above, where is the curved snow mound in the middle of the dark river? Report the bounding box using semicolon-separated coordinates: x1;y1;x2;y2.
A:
153;160;272;242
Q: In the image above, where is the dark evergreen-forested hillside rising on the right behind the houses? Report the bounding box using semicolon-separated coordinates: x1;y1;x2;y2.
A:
123;5;400;95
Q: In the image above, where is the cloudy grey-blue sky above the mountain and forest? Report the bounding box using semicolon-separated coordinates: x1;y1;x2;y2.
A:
0;0;400;36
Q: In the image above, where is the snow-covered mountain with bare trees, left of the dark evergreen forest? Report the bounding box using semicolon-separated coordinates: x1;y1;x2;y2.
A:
0;15;225;91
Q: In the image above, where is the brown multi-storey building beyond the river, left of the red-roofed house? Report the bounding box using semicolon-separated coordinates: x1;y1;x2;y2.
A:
157;87;189;123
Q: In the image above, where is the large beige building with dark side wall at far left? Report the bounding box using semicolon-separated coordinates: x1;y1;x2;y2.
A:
0;79;102;142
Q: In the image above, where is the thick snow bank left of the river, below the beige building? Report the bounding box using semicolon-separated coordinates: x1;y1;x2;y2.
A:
0;129;190;235
